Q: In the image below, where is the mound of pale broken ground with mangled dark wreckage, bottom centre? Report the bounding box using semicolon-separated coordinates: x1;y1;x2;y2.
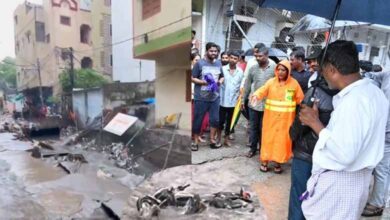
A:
121;157;267;220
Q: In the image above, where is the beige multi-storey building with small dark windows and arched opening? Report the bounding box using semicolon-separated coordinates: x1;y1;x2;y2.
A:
14;0;112;98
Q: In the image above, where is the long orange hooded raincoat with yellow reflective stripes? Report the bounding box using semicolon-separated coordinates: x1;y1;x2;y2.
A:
253;60;304;163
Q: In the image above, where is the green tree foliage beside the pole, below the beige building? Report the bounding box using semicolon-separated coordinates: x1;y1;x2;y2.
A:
60;69;108;92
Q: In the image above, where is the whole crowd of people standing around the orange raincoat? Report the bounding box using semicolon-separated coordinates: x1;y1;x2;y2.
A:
191;37;390;220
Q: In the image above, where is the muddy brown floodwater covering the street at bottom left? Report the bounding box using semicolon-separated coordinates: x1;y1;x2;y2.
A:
0;133;144;220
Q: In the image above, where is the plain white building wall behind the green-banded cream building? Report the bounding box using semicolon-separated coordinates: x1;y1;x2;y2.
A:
111;0;156;82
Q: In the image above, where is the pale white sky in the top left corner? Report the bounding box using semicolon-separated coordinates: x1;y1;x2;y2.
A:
0;0;42;60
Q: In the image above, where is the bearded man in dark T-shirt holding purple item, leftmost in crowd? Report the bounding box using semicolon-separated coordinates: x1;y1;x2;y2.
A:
191;42;224;151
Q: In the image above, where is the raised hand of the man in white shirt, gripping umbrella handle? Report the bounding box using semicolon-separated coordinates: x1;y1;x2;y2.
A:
299;102;324;135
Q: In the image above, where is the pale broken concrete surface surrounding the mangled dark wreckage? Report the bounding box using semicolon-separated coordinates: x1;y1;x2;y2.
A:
122;158;266;219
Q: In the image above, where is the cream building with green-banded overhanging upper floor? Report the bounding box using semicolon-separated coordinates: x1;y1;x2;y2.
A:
133;0;191;131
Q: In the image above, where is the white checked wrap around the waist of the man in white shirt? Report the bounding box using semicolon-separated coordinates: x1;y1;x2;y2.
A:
302;169;372;220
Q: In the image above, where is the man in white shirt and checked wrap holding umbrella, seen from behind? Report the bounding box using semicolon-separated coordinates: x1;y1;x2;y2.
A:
299;41;389;220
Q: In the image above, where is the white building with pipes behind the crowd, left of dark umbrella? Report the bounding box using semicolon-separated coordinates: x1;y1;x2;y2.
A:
192;0;303;54
